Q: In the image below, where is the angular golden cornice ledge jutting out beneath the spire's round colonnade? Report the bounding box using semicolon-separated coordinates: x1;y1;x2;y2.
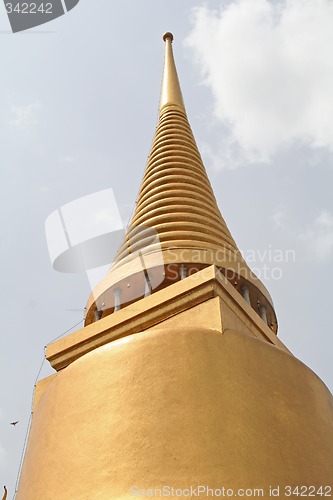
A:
46;265;286;371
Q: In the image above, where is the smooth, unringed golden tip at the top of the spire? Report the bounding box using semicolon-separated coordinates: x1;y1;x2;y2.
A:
160;32;185;111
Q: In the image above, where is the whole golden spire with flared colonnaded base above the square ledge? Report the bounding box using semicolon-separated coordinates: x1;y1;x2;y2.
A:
86;32;276;331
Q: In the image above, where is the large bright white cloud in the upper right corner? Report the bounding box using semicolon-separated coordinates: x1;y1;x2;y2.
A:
186;0;333;161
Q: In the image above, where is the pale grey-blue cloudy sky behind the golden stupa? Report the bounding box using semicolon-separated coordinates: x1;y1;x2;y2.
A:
0;0;333;498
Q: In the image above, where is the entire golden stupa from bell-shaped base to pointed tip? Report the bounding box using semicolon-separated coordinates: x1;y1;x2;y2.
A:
17;33;333;500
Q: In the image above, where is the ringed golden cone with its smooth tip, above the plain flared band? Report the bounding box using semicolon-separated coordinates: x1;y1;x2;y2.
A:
111;32;240;263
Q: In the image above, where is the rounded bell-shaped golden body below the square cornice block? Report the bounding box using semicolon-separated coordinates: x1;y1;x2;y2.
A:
17;328;333;500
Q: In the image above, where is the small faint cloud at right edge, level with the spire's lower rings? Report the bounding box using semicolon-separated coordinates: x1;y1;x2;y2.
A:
301;210;333;261
